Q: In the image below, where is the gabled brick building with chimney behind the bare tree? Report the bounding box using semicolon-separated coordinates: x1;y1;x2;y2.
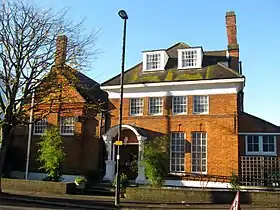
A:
12;35;108;179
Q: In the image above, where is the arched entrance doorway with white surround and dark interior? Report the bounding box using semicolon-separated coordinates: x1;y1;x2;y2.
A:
103;124;146;184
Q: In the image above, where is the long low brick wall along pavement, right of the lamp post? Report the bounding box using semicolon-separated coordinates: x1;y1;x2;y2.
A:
126;187;280;205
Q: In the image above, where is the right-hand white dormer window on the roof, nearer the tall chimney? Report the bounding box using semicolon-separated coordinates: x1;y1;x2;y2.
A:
178;47;203;69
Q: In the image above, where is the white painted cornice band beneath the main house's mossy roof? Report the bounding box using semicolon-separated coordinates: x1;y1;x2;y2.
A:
101;78;245;99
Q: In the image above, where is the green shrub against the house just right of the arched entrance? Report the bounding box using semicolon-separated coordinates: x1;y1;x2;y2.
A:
141;136;169;186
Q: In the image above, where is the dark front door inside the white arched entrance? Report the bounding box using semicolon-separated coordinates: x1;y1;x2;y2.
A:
115;144;138;180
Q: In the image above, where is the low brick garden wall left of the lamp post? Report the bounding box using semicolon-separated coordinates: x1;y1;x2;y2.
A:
1;179;76;194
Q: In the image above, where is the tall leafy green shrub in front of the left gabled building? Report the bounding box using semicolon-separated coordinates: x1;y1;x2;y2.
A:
38;127;65;181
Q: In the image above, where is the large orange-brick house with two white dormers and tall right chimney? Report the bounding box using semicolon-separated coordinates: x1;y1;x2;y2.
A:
101;12;280;184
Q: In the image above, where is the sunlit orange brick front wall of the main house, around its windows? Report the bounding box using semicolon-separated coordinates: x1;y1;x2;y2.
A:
110;94;238;175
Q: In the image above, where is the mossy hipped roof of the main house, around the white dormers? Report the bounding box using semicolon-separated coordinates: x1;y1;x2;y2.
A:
101;42;243;86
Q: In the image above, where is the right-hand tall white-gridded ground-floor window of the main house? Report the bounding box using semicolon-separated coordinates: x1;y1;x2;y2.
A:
192;132;207;173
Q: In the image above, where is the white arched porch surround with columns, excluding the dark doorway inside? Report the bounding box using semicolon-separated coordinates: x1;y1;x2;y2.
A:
102;124;147;184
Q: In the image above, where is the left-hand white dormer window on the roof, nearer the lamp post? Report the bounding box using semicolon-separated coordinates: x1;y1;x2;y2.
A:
143;50;168;71
